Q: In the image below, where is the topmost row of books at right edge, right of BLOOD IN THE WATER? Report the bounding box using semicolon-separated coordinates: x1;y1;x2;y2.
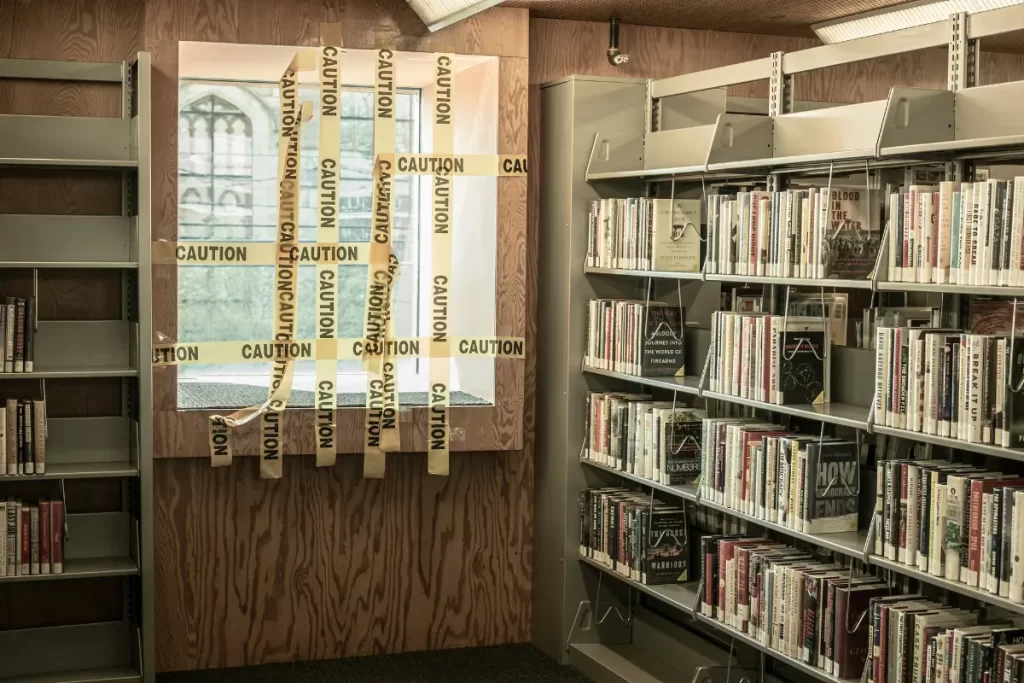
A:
887;177;1024;287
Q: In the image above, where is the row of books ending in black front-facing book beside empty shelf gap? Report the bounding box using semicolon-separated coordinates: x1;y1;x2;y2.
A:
709;311;830;404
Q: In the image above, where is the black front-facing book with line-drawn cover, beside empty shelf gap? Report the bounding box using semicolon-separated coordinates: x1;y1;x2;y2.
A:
778;317;828;404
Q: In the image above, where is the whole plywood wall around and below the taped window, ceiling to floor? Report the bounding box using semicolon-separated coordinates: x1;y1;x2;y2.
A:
145;0;532;671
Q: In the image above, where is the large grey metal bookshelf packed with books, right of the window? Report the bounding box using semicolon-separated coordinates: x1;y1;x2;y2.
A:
534;6;1024;683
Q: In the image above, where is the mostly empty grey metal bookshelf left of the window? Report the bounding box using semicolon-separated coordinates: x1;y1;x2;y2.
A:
0;52;155;683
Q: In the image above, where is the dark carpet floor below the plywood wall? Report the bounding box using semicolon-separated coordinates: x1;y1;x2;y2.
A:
157;645;590;683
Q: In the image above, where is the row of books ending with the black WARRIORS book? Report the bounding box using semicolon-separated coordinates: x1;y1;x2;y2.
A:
580;487;689;586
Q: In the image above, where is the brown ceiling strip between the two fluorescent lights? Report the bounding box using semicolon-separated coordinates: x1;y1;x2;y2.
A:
504;0;925;36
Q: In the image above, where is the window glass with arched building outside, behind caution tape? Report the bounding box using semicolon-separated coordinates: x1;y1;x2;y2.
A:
178;82;429;408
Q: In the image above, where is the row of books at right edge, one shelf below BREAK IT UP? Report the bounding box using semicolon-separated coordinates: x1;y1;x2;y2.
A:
874;459;1024;602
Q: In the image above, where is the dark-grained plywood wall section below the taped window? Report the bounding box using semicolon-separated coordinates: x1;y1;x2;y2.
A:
155;454;530;671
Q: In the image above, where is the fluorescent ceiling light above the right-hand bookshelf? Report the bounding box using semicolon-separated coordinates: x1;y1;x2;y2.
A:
811;0;1024;45
